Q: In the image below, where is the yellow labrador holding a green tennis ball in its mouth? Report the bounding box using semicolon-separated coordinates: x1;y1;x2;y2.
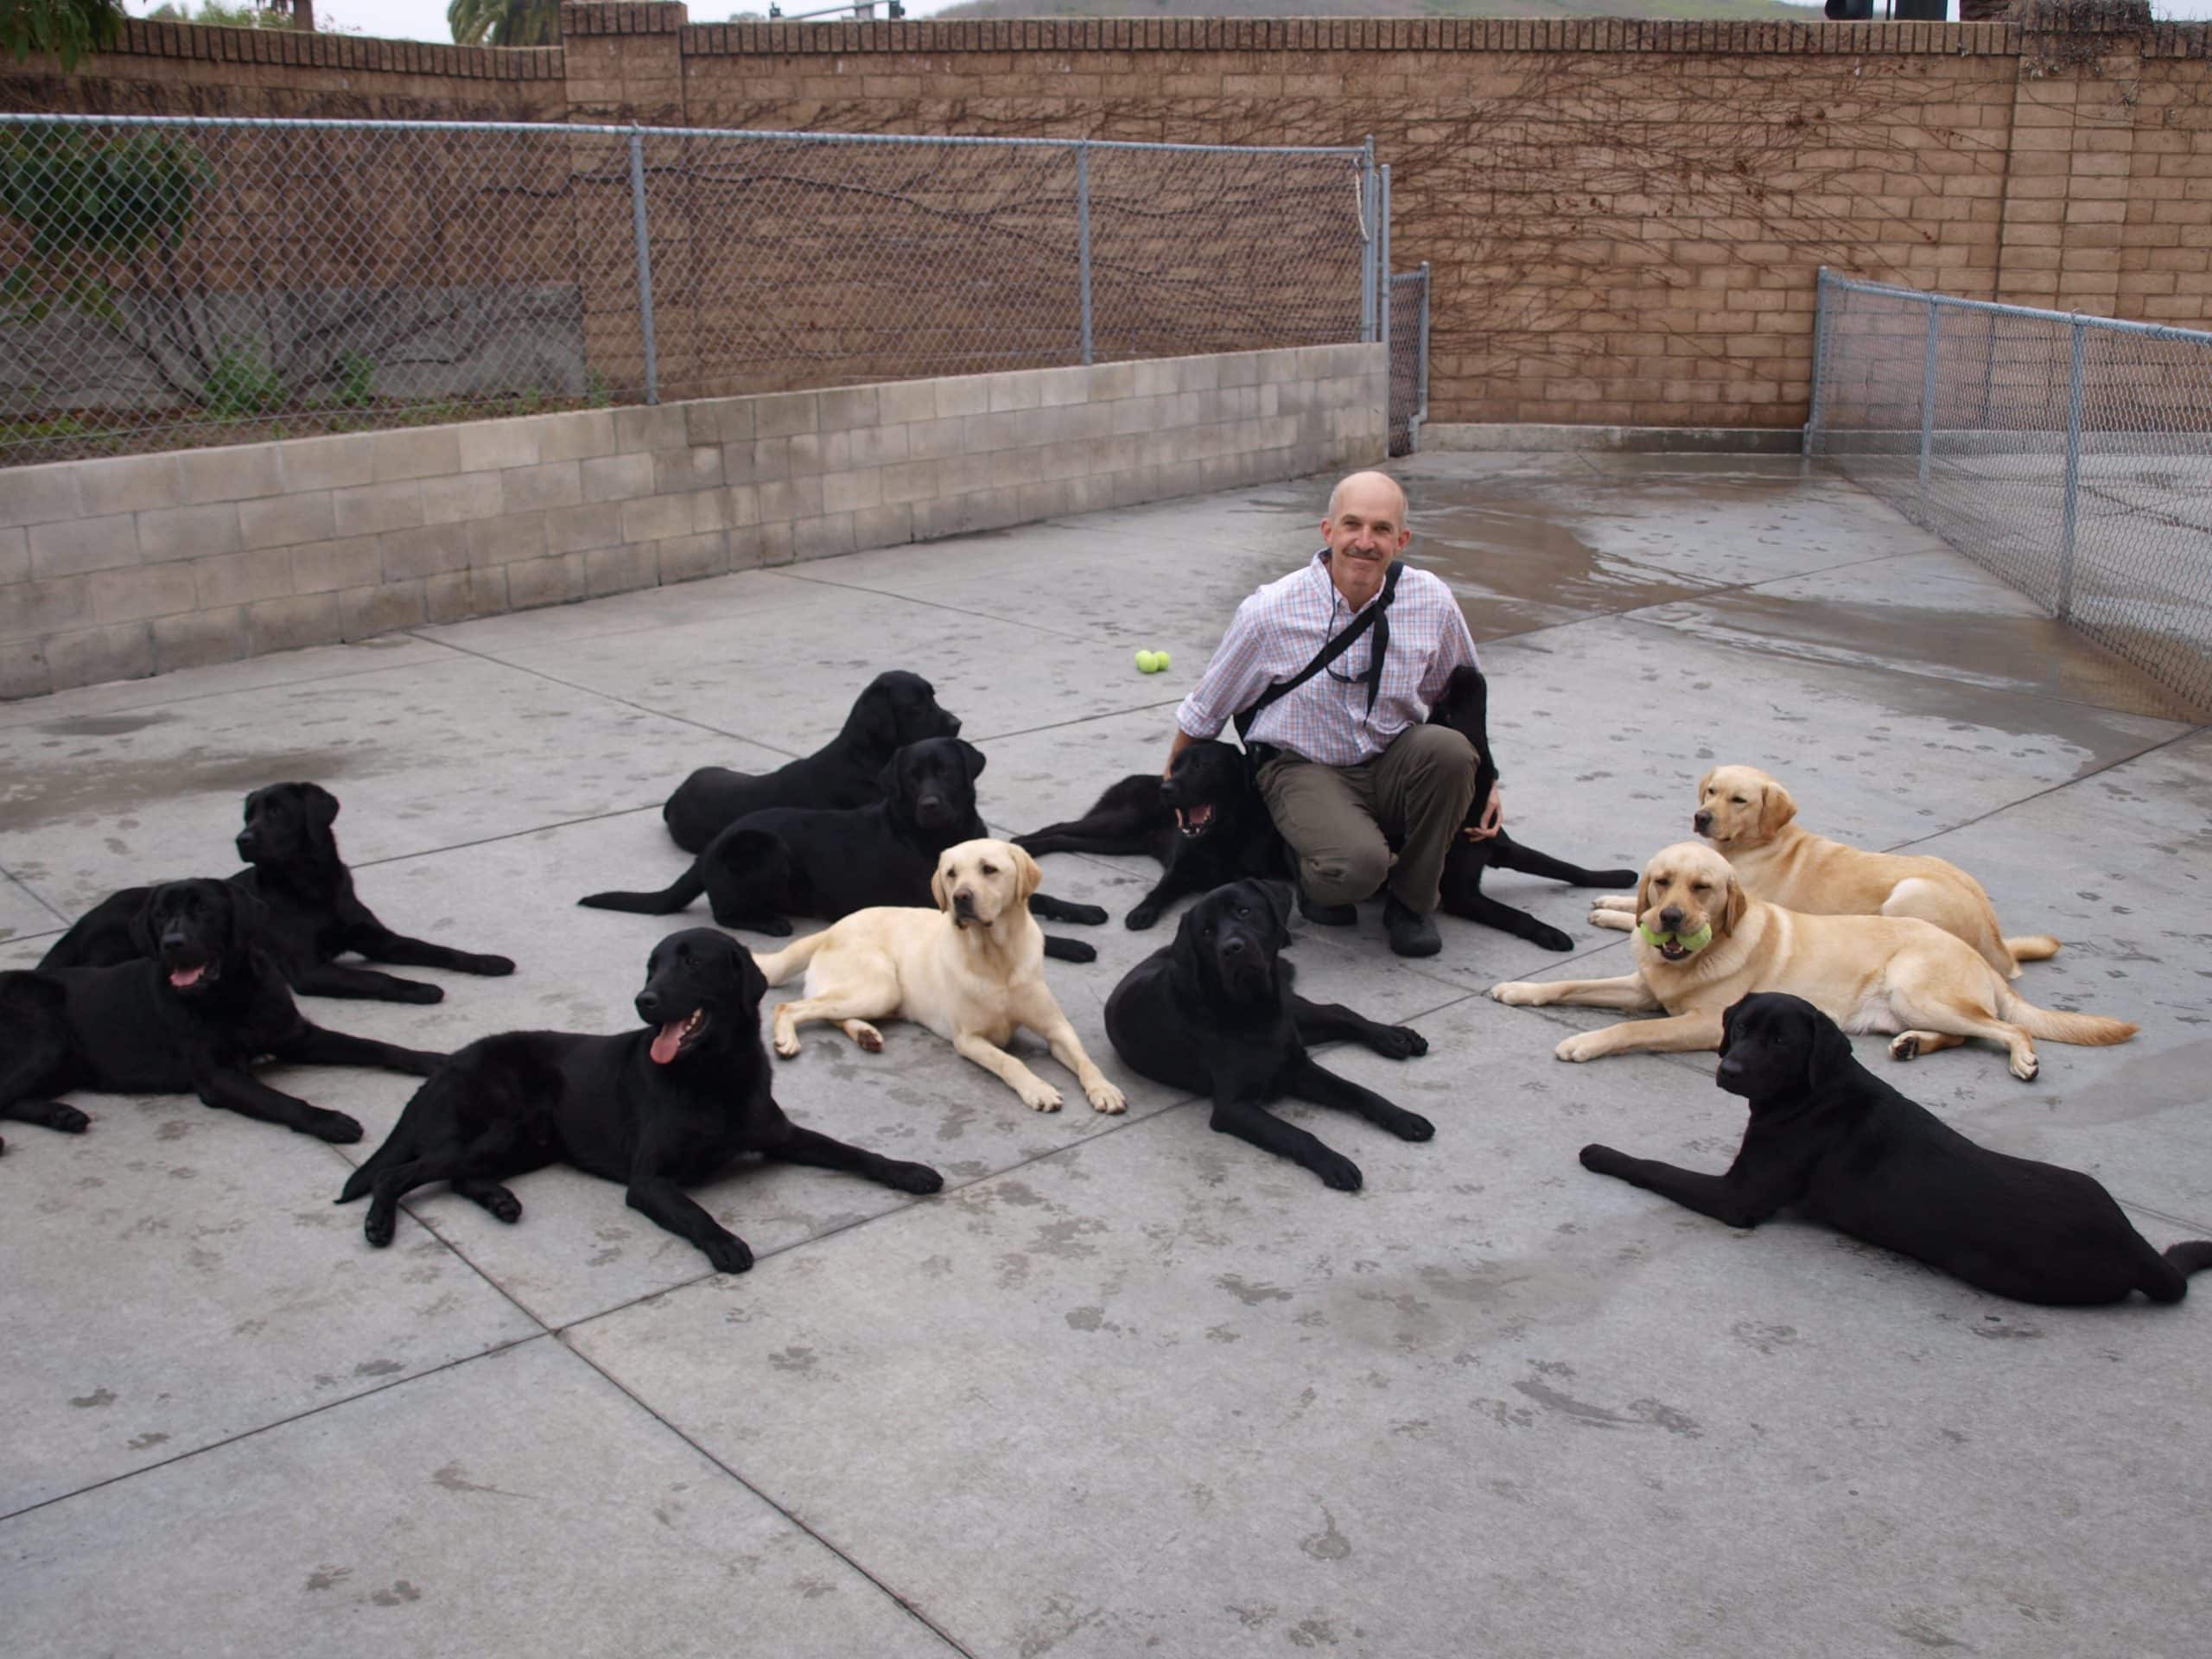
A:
1491;841;2134;1079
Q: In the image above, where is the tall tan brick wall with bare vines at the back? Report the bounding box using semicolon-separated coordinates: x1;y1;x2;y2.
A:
17;4;2212;427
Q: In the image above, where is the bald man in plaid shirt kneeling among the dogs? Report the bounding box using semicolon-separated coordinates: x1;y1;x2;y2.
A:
1168;474;1497;956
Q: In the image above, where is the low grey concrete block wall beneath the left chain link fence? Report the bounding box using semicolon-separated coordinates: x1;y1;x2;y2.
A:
0;345;1385;696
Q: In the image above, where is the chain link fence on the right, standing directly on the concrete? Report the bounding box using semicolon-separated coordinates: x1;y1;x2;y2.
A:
1805;270;2212;706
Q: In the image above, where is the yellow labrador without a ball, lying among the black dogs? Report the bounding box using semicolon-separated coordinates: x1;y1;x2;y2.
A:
759;841;1128;1113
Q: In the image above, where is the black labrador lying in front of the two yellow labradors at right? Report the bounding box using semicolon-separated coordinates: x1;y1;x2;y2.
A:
1581;991;2212;1307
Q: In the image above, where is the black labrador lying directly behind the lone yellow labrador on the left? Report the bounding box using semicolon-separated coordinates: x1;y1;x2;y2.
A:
577;736;1106;963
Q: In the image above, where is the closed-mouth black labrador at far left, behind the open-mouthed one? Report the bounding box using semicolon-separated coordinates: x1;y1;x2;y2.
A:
40;783;515;1002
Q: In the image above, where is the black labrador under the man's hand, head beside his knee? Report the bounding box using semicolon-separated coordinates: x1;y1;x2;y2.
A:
1013;741;1289;929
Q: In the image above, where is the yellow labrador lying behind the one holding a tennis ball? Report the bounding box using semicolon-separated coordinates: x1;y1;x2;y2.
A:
1591;766;2059;980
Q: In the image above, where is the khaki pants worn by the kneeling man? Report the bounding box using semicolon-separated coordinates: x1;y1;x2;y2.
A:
1259;726;1476;916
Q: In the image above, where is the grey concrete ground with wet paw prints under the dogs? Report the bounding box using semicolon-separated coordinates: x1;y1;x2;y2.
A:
0;455;2212;1659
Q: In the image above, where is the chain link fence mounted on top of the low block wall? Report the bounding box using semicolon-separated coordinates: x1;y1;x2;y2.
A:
0;115;1387;465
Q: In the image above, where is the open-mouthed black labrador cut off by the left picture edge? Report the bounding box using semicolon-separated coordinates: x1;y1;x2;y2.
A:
0;880;445;1141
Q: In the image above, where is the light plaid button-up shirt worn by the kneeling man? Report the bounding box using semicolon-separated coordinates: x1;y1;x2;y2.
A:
1174;549;1476;766
